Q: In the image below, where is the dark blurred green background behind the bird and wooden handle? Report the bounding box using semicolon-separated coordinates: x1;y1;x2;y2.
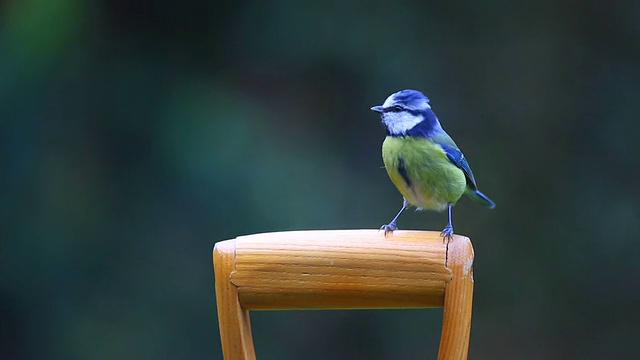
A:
0;0;640;360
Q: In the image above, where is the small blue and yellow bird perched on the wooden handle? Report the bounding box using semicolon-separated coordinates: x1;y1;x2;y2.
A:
371;89;496;240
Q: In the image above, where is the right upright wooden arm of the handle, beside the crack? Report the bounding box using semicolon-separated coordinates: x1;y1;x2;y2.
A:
438;235;473;360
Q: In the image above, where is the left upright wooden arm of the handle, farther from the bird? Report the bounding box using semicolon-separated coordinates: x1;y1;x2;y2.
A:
213;240;256;360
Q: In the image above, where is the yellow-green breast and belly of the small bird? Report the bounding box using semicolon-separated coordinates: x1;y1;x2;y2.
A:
382;136;466;211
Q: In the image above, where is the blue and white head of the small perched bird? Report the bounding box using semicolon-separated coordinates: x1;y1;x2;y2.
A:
371;89;439;135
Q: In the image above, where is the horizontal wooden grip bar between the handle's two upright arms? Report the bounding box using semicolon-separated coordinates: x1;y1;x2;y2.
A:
231;230;451;310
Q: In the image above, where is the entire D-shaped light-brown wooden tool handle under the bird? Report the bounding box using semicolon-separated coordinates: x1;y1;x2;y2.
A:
213;230;473;360
